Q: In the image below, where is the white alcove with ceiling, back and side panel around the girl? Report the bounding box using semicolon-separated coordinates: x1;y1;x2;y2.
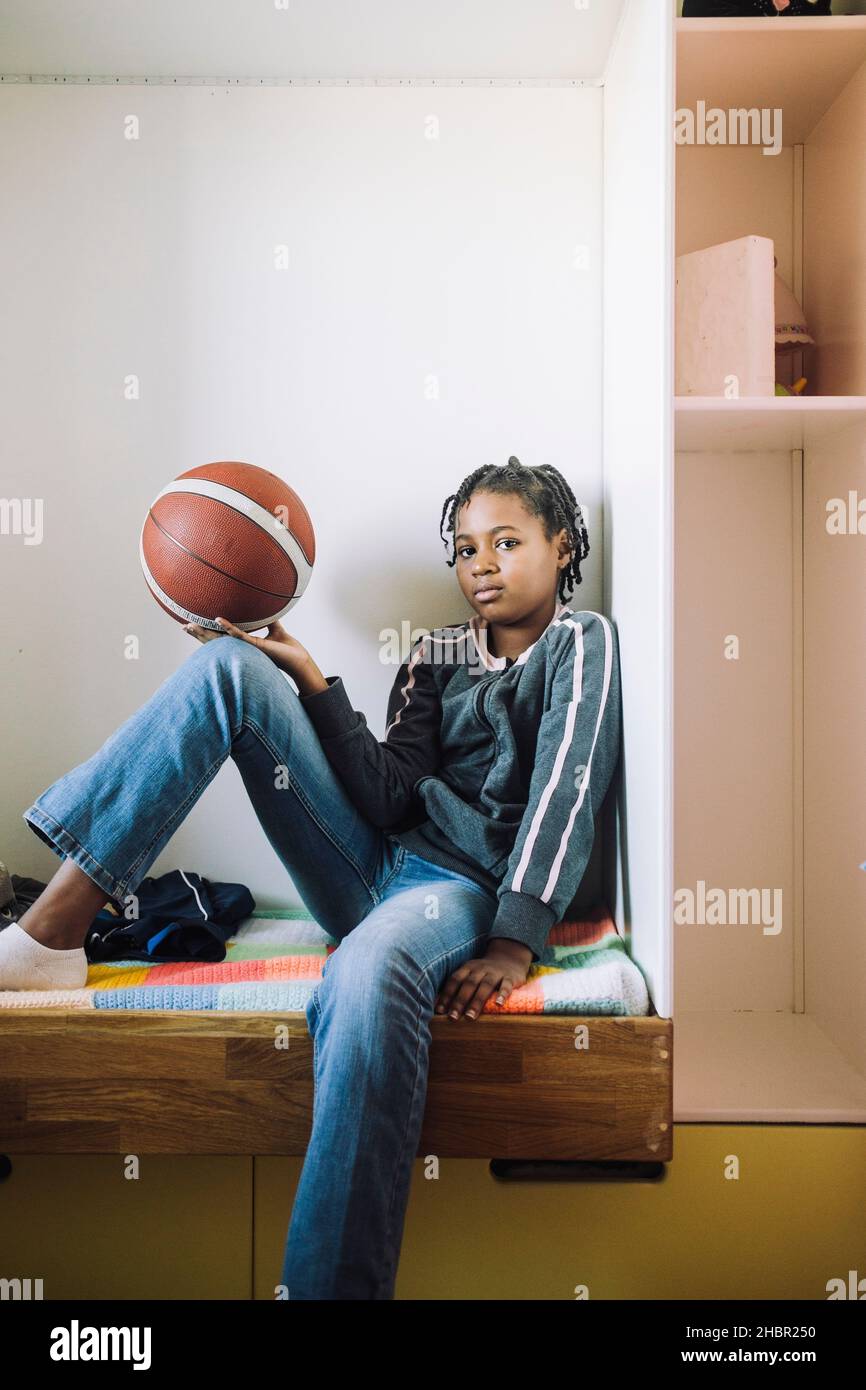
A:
0;0;674;1156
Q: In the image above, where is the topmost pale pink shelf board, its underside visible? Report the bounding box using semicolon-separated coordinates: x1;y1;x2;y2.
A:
676;15;866;146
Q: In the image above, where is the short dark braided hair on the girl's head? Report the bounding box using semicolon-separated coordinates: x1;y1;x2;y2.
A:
439;455;589;600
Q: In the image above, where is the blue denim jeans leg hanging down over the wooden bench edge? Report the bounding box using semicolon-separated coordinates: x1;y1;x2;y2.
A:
282;853;496;1300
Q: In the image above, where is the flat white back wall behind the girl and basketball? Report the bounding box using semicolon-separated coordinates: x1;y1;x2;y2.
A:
0;85;603;906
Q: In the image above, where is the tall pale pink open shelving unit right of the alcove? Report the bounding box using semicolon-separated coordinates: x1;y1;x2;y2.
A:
674;17;866;1123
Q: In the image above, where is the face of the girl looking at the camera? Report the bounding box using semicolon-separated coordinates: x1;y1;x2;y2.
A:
455;492;571;624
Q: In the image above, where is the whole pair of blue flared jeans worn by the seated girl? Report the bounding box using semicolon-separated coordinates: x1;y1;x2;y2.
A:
24;635;496;1300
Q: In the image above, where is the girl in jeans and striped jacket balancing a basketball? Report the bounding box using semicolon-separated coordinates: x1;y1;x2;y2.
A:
0;457;620;1300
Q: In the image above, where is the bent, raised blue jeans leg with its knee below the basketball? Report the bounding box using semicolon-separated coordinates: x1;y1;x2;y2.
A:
24;635;395;938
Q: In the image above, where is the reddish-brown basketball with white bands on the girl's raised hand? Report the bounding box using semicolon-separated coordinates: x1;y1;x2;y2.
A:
139;463;316;632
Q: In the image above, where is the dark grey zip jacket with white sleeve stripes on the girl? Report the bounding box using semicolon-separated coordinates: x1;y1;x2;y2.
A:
302;603;621;960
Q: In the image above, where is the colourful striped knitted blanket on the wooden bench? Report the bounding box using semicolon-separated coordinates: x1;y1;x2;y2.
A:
0;906;651;1015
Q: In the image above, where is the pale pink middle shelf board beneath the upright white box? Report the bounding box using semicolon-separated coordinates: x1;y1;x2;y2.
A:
674;396;866;453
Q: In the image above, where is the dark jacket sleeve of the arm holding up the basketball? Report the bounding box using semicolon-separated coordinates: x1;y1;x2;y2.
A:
300;638;442;830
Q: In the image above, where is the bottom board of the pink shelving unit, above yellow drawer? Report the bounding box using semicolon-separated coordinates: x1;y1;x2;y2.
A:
674;1011;866;1125
